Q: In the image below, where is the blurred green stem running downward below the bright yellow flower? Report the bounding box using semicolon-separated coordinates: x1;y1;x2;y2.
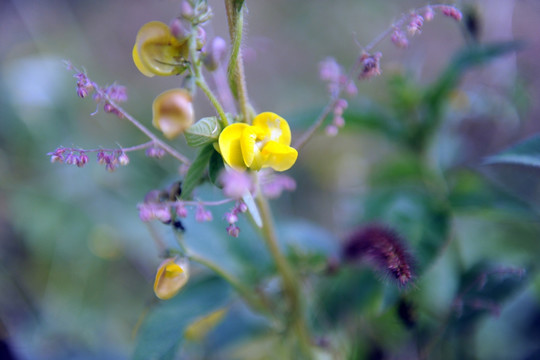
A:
255;184;311;359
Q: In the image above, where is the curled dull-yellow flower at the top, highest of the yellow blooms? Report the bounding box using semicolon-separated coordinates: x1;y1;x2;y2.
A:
132;21;189;77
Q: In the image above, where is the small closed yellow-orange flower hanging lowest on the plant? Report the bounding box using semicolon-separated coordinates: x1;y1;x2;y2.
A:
154;258;189;300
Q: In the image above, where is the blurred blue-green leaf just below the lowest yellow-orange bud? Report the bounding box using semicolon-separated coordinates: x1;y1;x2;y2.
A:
133;277;230;360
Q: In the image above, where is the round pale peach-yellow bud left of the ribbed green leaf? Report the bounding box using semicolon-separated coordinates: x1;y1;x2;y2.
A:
152;89;194;139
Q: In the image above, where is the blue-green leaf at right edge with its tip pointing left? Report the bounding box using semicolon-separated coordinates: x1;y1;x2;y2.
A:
484;135;540;206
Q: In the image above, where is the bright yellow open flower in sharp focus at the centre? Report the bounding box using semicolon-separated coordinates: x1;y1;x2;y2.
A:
218;112;298;171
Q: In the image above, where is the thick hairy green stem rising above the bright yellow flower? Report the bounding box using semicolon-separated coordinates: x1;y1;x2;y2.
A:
225;0;254;124
